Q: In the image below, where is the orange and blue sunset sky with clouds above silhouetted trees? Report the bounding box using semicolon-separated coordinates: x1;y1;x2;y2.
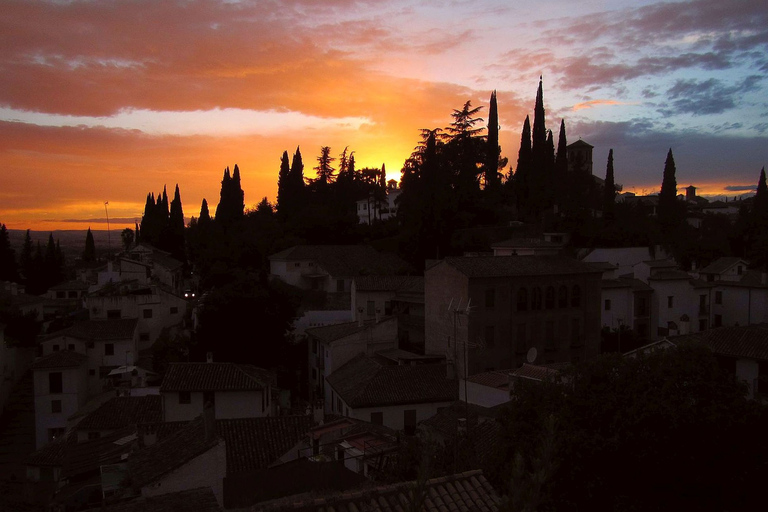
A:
0;0;768;230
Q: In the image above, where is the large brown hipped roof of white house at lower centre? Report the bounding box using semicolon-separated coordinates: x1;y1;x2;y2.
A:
327;354;459;407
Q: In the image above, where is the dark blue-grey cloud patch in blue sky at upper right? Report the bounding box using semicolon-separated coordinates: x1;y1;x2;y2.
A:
659;75;763;116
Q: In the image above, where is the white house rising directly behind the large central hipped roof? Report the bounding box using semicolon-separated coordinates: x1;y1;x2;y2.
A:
306;316;397;404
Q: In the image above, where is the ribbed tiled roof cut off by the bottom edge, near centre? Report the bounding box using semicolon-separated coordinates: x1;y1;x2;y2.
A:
252;470;500;512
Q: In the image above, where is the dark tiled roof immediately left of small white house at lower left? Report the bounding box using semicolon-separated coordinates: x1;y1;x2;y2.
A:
77;395;163;430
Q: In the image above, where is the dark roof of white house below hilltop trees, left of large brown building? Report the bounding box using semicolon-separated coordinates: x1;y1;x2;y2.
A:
269;245;410;277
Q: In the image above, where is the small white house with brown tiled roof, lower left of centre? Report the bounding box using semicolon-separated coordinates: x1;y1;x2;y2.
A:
160;362;276;421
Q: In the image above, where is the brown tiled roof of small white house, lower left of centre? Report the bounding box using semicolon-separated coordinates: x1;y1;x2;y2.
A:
160;363;274;392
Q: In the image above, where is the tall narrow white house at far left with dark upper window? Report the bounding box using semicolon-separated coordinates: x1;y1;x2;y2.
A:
32;350;88;449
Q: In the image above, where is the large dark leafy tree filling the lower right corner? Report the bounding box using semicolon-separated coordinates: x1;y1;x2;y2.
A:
487;342;768;511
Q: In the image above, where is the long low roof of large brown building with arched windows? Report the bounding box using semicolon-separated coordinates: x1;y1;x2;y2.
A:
443;256;601;277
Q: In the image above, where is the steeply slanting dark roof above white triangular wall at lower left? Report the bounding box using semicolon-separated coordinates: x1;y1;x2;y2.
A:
128;416;221;488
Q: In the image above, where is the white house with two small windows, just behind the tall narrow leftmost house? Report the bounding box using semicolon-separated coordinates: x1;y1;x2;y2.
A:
41;319;138;394
